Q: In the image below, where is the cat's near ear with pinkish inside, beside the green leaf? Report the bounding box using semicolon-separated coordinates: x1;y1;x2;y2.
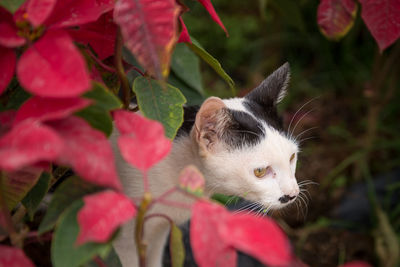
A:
192;97;227;154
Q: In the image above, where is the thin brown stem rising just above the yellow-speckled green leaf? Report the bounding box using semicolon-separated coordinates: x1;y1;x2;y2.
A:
114;28;131;109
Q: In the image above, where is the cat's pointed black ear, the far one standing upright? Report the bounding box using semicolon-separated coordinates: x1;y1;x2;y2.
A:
246;62;290;106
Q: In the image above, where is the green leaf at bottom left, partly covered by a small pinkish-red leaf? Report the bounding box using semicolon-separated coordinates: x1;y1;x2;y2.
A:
51;200;111;267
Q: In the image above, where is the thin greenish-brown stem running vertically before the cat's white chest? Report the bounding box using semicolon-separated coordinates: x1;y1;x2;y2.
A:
134;192;152;267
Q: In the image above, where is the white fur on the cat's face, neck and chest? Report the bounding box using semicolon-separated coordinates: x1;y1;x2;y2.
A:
111;101;299;267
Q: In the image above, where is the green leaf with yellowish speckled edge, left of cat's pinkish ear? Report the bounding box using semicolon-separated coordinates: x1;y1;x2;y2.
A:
133;77;186;139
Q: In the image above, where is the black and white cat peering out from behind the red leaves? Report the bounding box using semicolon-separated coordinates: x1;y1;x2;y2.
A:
111;63;299;267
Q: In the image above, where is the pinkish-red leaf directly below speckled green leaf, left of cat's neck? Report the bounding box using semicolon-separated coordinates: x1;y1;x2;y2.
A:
114;110;172;171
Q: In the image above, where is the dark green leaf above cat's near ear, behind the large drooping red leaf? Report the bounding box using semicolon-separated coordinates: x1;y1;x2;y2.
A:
171;43;204;95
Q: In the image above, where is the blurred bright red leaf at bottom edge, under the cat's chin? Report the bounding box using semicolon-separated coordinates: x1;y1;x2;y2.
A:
219;214;293;266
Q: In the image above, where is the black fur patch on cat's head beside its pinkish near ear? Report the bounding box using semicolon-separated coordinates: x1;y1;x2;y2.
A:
222;109;265;148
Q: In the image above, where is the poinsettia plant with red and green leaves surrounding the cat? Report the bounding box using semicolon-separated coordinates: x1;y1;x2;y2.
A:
0;0;400;266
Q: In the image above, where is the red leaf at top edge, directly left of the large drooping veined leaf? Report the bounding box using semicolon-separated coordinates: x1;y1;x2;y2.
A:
45;0;115;28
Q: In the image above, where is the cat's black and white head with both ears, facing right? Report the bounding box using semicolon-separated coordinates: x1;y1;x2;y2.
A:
191;63;299;209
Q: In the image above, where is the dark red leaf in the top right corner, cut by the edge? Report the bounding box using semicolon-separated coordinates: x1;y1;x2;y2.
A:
360;0;400;51
